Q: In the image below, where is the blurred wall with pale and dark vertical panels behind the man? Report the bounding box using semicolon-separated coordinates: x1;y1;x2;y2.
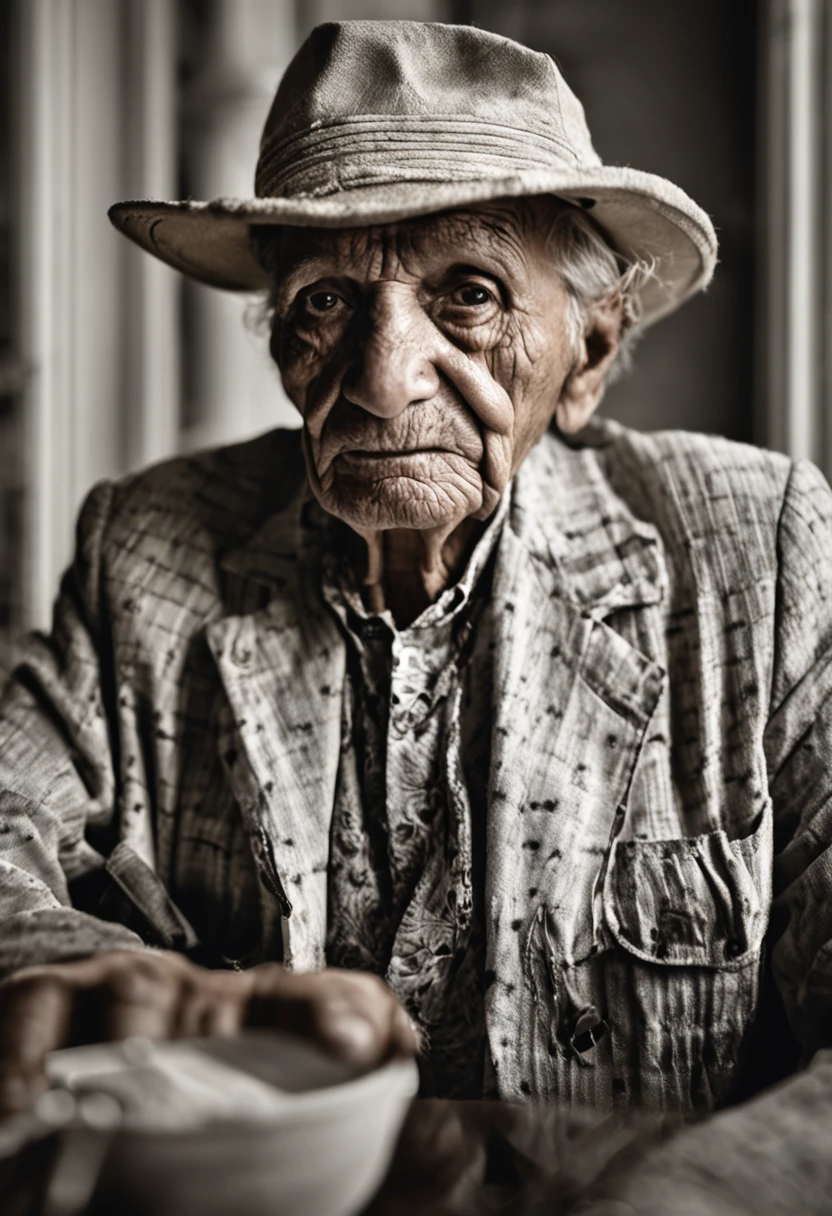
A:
0;0;832;662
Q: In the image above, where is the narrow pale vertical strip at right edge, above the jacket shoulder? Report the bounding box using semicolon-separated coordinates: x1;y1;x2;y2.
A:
759;0;832;477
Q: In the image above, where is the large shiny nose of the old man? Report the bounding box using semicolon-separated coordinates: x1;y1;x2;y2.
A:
342;285;439;418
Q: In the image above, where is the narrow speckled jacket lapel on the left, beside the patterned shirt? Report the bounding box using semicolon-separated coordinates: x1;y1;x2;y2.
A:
208;500;345;970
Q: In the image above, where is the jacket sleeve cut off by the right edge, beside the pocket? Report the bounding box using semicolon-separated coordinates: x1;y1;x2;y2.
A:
764;462;832;1059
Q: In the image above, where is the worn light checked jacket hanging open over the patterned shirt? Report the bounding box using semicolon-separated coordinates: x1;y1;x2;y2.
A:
0;423;832;1110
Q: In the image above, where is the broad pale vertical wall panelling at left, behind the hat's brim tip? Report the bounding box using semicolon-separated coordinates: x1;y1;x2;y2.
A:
17;0;179;626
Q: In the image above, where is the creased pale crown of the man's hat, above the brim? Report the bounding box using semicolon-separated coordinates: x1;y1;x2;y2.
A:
255;21;600;197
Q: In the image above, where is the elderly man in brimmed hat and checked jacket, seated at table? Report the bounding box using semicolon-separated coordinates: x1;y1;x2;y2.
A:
0;22;832;1157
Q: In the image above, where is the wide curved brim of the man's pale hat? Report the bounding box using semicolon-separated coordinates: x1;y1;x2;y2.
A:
108;165;716;325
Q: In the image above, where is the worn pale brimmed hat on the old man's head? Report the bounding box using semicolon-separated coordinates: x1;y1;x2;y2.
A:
109;21;716;323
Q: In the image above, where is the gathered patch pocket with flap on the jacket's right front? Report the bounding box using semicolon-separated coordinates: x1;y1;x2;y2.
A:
603;807;771;1110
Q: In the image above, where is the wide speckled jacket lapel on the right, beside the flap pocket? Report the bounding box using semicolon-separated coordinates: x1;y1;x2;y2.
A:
485;438;664;1097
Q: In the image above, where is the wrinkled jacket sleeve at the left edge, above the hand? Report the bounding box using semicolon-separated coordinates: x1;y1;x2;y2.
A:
0;484;142;976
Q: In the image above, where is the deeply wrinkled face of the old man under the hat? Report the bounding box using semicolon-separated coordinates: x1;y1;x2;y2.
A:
271;199;572;533
